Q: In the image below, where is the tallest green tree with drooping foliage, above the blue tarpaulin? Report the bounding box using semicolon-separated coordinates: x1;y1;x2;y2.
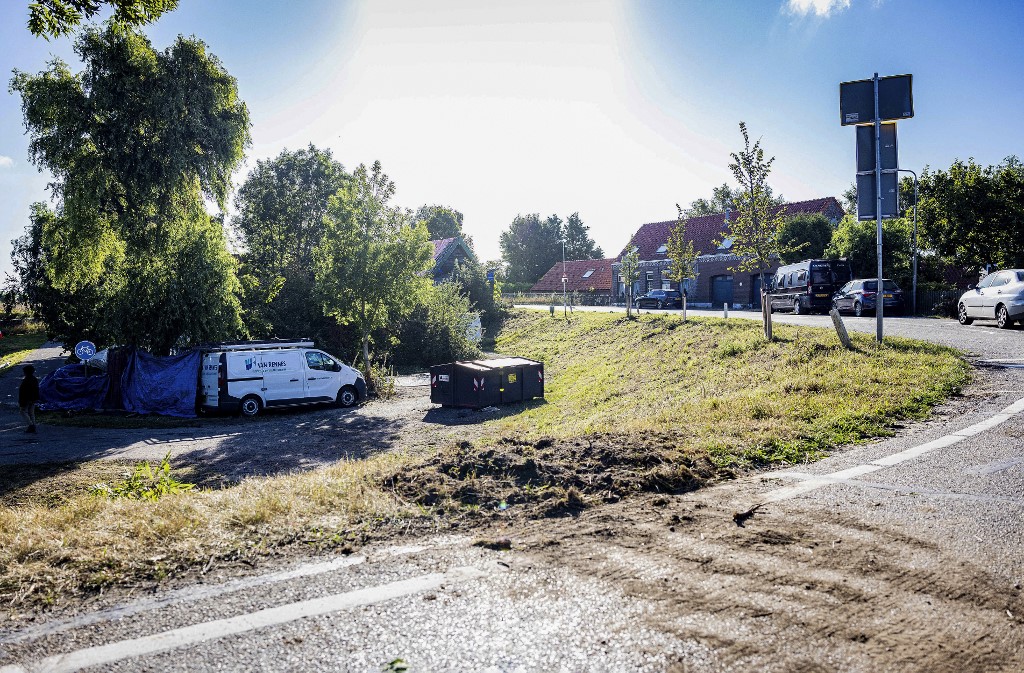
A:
11;28;250;352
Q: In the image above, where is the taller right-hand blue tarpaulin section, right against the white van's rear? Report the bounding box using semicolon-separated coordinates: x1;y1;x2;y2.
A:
121;350;200;418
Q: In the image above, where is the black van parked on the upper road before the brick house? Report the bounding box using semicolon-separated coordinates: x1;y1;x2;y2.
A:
769;259;853;314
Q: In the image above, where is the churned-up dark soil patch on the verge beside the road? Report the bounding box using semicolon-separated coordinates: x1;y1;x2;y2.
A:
385;433;731;516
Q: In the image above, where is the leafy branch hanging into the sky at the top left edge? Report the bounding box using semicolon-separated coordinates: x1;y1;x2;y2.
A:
29;0;179;40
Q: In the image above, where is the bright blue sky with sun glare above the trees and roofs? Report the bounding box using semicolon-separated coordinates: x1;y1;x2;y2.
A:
0;0;1024;274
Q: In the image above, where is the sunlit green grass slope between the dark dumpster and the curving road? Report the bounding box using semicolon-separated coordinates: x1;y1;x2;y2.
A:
494;311;970;465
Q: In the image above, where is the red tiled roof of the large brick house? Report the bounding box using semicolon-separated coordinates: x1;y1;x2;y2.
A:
613;197;844;261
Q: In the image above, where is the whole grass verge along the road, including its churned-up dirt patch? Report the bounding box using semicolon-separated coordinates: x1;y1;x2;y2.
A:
0;311;970;609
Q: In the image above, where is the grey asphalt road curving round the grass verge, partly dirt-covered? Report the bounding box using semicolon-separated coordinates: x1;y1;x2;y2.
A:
0;315;1024;673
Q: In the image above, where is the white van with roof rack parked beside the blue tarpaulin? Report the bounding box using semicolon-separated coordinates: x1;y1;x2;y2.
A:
200;341;367;416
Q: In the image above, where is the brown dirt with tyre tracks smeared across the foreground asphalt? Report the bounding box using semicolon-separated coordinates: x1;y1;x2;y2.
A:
512;493;1024;673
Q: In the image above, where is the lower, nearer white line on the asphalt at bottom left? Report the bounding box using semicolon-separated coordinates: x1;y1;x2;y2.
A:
0;566;488;673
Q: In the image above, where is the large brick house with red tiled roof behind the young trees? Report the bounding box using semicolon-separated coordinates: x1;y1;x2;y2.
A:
612;197;846;307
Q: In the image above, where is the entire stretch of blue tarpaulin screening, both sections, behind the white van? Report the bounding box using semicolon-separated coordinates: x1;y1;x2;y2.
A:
39;348;200;418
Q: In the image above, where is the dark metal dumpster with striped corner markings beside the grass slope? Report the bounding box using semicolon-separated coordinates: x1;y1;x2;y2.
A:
430;357;544;409
